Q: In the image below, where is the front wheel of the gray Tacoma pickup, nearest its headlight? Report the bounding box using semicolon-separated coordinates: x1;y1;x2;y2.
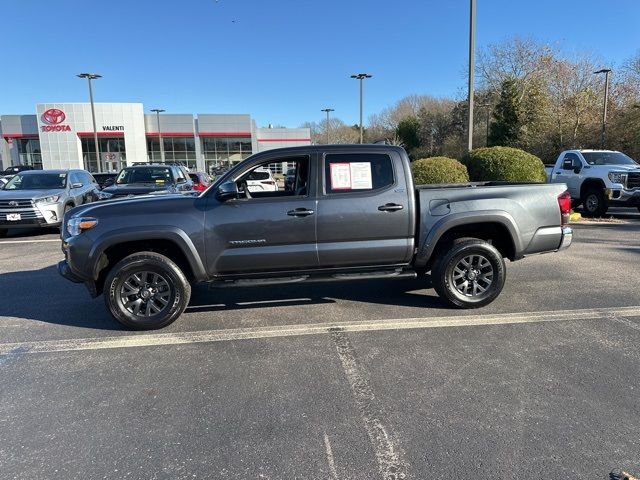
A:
104;252;191;330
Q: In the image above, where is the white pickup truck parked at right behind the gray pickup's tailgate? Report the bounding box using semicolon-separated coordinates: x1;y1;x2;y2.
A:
546;150;640;217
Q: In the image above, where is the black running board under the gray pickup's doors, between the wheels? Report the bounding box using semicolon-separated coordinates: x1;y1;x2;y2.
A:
209;269;417;288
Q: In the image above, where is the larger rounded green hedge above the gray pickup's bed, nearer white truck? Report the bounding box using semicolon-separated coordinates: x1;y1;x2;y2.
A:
462;147;547;183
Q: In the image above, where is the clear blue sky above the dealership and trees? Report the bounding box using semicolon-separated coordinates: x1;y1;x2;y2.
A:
0;0;640;127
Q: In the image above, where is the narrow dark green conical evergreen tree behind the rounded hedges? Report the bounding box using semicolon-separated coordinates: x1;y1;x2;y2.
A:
489;79;521;146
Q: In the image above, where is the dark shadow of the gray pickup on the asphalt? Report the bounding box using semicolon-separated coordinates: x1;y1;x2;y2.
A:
0;265;446;330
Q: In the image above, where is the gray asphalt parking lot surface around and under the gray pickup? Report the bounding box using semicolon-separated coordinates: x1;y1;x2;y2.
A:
0;211;640;480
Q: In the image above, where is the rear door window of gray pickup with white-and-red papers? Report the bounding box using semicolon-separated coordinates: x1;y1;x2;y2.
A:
324;153;395;194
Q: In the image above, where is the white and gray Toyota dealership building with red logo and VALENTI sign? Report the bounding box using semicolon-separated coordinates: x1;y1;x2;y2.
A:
0;103;311;173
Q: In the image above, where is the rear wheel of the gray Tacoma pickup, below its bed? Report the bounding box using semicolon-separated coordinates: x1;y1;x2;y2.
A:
431;238;506;308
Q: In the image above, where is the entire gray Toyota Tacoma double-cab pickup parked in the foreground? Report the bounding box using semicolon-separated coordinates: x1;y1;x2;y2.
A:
58;145;572;329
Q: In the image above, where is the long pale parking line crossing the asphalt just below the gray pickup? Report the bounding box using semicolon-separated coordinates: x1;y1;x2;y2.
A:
0;305;640;355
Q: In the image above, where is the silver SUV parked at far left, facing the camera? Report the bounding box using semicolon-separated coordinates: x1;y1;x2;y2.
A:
0;170;100;237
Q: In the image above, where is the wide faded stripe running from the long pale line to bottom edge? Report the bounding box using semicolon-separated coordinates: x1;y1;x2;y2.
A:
330;330;407;480
